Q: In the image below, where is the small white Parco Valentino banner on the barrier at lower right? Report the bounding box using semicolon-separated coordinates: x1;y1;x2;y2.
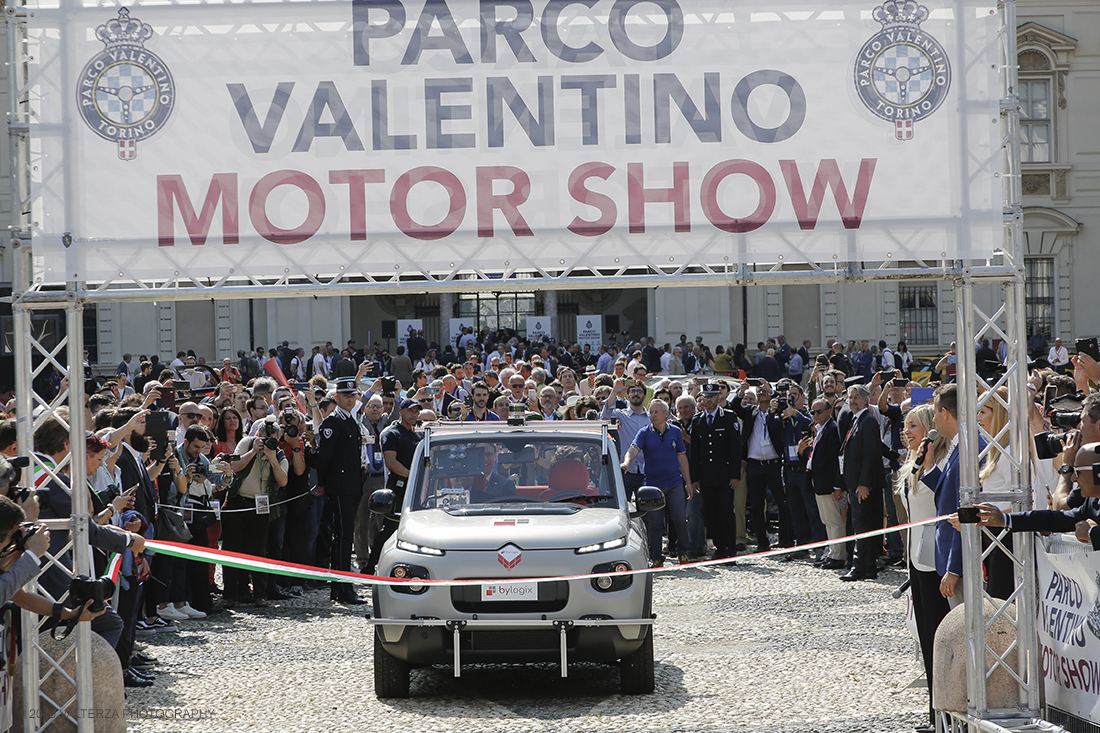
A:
1035;537;1100;724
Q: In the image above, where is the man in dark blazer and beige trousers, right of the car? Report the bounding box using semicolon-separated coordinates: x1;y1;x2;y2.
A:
806;397;848;570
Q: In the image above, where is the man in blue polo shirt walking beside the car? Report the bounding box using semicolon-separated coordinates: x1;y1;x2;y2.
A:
622;400;695;568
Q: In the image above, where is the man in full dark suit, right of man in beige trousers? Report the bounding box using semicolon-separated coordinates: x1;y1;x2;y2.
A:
840;384;887;580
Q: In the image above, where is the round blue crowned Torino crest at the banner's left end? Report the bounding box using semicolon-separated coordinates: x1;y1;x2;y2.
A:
77;8;176;161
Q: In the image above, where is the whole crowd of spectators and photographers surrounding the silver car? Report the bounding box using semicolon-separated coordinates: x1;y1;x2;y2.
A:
0;330;1100;730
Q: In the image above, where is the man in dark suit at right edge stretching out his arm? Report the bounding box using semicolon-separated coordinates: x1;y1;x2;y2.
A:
972;442;1100;550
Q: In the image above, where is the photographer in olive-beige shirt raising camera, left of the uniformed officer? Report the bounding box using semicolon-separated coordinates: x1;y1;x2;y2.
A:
221;416;289;608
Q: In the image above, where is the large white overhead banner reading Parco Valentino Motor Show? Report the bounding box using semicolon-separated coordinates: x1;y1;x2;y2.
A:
28;0;1002;282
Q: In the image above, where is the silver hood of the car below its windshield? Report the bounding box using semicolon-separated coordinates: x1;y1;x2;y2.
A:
397;506;629;550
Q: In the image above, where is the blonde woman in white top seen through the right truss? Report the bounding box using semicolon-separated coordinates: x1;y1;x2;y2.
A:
978;386;1015;600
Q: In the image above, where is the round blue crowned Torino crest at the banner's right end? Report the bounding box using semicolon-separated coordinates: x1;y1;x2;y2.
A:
855;0;952;140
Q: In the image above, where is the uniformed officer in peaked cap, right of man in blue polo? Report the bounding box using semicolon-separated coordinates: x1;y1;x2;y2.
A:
688;383;741;559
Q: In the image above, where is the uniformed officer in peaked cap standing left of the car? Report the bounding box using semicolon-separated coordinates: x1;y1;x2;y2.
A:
314;378;366;604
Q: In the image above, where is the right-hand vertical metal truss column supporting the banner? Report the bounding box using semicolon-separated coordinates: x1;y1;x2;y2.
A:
953;0;1038;731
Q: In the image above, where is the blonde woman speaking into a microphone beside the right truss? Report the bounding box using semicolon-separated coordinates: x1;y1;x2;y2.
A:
895;405;950;726
